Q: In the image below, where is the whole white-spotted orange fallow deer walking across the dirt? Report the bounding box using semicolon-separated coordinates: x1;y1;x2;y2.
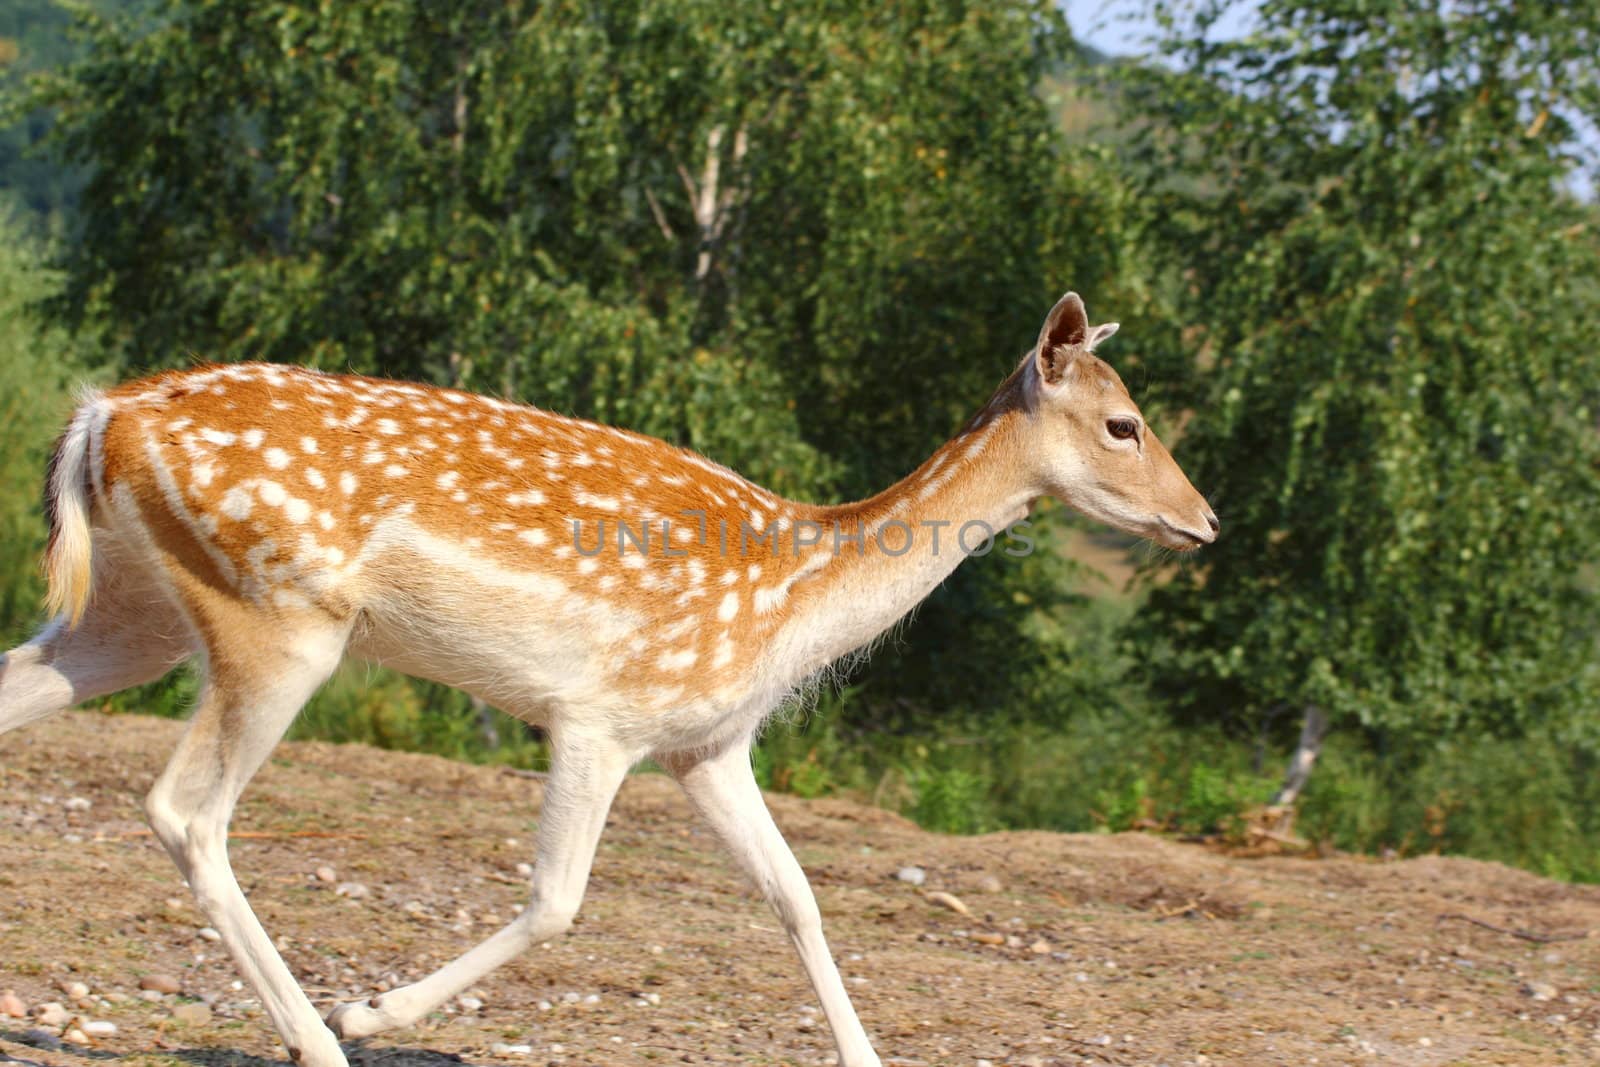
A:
0;293;1218;1067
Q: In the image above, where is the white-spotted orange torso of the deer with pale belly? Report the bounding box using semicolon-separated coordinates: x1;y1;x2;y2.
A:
98;363;825;735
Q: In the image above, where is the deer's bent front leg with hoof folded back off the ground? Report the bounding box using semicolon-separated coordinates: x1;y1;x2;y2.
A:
328;736;634;1040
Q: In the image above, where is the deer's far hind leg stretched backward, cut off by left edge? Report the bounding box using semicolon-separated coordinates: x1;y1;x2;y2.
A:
0;539;195;734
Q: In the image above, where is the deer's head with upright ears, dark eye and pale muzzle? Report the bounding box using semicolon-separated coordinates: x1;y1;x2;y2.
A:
1021;293;1221;550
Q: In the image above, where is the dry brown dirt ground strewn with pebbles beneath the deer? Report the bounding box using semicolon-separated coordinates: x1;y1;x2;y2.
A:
0;712;1600;1067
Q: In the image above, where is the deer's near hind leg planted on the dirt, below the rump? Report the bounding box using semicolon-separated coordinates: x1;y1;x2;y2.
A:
146;609;349;1067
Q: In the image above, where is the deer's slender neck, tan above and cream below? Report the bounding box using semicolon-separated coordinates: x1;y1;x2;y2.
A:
779;406;1038;677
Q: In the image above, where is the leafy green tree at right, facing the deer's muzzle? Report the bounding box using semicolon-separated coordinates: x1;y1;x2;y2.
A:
1125;0;1600;796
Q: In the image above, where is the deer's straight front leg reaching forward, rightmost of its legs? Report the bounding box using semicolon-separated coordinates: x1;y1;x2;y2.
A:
658;739;880;1067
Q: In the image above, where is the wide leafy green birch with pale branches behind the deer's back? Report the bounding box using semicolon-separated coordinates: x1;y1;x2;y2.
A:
34;0;1128;735
